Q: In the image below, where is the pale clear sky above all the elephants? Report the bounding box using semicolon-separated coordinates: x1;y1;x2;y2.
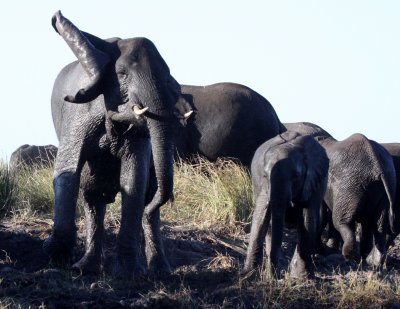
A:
0;0;400;159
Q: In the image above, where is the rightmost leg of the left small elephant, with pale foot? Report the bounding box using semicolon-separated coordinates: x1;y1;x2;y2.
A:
290;202;319;279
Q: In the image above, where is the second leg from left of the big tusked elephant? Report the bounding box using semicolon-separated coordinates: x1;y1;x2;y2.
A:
72;202;106;274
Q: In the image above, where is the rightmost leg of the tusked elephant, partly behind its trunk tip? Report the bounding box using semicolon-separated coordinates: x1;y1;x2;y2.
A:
142;167;171;274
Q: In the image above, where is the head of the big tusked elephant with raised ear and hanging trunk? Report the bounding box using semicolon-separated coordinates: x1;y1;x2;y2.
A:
52;11;180;214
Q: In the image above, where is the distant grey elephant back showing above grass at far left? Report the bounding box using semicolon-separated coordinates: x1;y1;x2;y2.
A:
9;144;57;169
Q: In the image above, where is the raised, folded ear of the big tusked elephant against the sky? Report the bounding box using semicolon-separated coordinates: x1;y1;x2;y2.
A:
52;11;111;103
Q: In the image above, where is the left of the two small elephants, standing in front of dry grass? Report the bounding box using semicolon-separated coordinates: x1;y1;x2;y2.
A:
243;131;329;278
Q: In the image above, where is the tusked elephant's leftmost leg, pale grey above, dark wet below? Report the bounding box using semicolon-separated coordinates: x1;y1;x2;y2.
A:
43;145;82;266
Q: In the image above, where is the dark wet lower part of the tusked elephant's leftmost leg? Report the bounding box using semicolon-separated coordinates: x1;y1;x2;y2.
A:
43;171;79;266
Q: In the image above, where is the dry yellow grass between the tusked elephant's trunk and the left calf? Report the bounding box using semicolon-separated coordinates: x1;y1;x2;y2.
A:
161;157;253;228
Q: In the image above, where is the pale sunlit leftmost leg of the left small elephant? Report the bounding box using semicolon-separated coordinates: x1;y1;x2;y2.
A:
242;193;271;275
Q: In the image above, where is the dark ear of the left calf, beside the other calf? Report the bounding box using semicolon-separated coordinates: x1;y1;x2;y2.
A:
302;136;329;201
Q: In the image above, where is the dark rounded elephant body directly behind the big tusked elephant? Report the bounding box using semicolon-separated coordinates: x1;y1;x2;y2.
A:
175;83;285;167
